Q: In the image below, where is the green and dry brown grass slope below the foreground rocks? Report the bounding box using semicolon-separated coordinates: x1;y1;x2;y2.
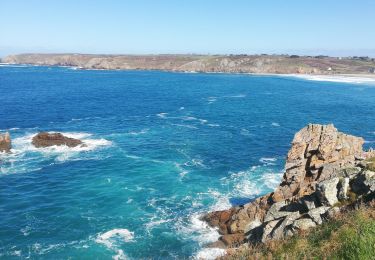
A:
223;201;375;260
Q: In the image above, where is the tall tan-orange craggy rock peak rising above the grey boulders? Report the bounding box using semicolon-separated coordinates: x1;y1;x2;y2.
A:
272;124;364;202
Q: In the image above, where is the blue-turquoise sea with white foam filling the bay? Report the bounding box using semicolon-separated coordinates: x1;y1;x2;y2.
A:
0;66;375;259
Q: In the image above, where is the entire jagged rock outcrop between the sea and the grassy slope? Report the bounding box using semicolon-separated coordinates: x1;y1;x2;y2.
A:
203;124;375;247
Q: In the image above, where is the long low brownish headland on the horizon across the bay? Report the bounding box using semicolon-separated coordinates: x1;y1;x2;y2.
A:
2;54;375;74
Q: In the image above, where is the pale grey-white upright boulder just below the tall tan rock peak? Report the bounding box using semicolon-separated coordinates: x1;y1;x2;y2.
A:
316;177;340;206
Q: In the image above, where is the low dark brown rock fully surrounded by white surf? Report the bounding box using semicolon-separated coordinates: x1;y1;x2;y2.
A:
32;132;83;148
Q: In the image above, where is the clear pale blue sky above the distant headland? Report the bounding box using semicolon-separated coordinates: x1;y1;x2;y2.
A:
0;0;375;57
